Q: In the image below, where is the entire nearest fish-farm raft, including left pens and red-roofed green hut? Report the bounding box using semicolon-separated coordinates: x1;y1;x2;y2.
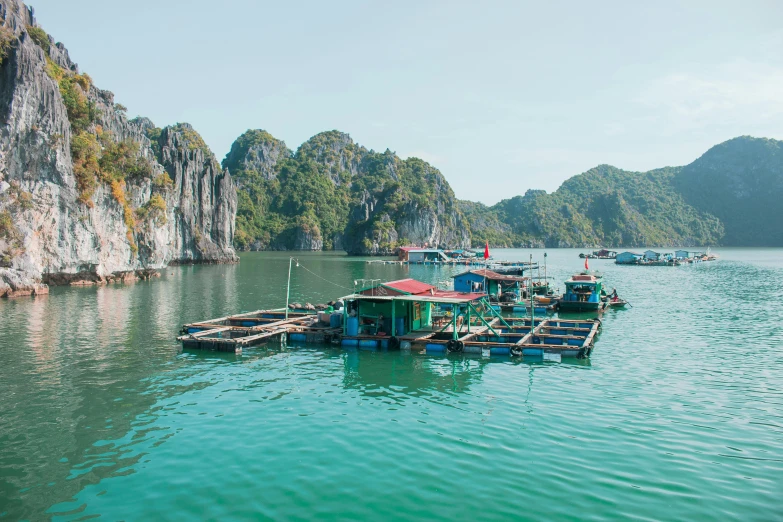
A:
177;279;601;360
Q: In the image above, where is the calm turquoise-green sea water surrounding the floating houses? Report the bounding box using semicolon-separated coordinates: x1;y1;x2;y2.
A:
0;249;783;521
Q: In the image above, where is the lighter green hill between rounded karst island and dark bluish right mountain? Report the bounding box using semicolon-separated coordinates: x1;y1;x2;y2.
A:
462;165;723;247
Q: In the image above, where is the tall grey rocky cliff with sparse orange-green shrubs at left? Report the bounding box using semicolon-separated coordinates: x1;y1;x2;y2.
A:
0;0;237;295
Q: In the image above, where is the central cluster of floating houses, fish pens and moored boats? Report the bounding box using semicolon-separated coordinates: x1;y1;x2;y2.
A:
178;247;648;361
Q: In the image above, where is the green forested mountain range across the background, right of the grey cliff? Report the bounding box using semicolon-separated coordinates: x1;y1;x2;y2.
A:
223;130;783;249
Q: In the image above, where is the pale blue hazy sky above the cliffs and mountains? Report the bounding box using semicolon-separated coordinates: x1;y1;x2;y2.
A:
29;0;783;204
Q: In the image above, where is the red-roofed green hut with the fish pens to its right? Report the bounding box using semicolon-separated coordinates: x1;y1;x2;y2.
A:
333;280;601;359
